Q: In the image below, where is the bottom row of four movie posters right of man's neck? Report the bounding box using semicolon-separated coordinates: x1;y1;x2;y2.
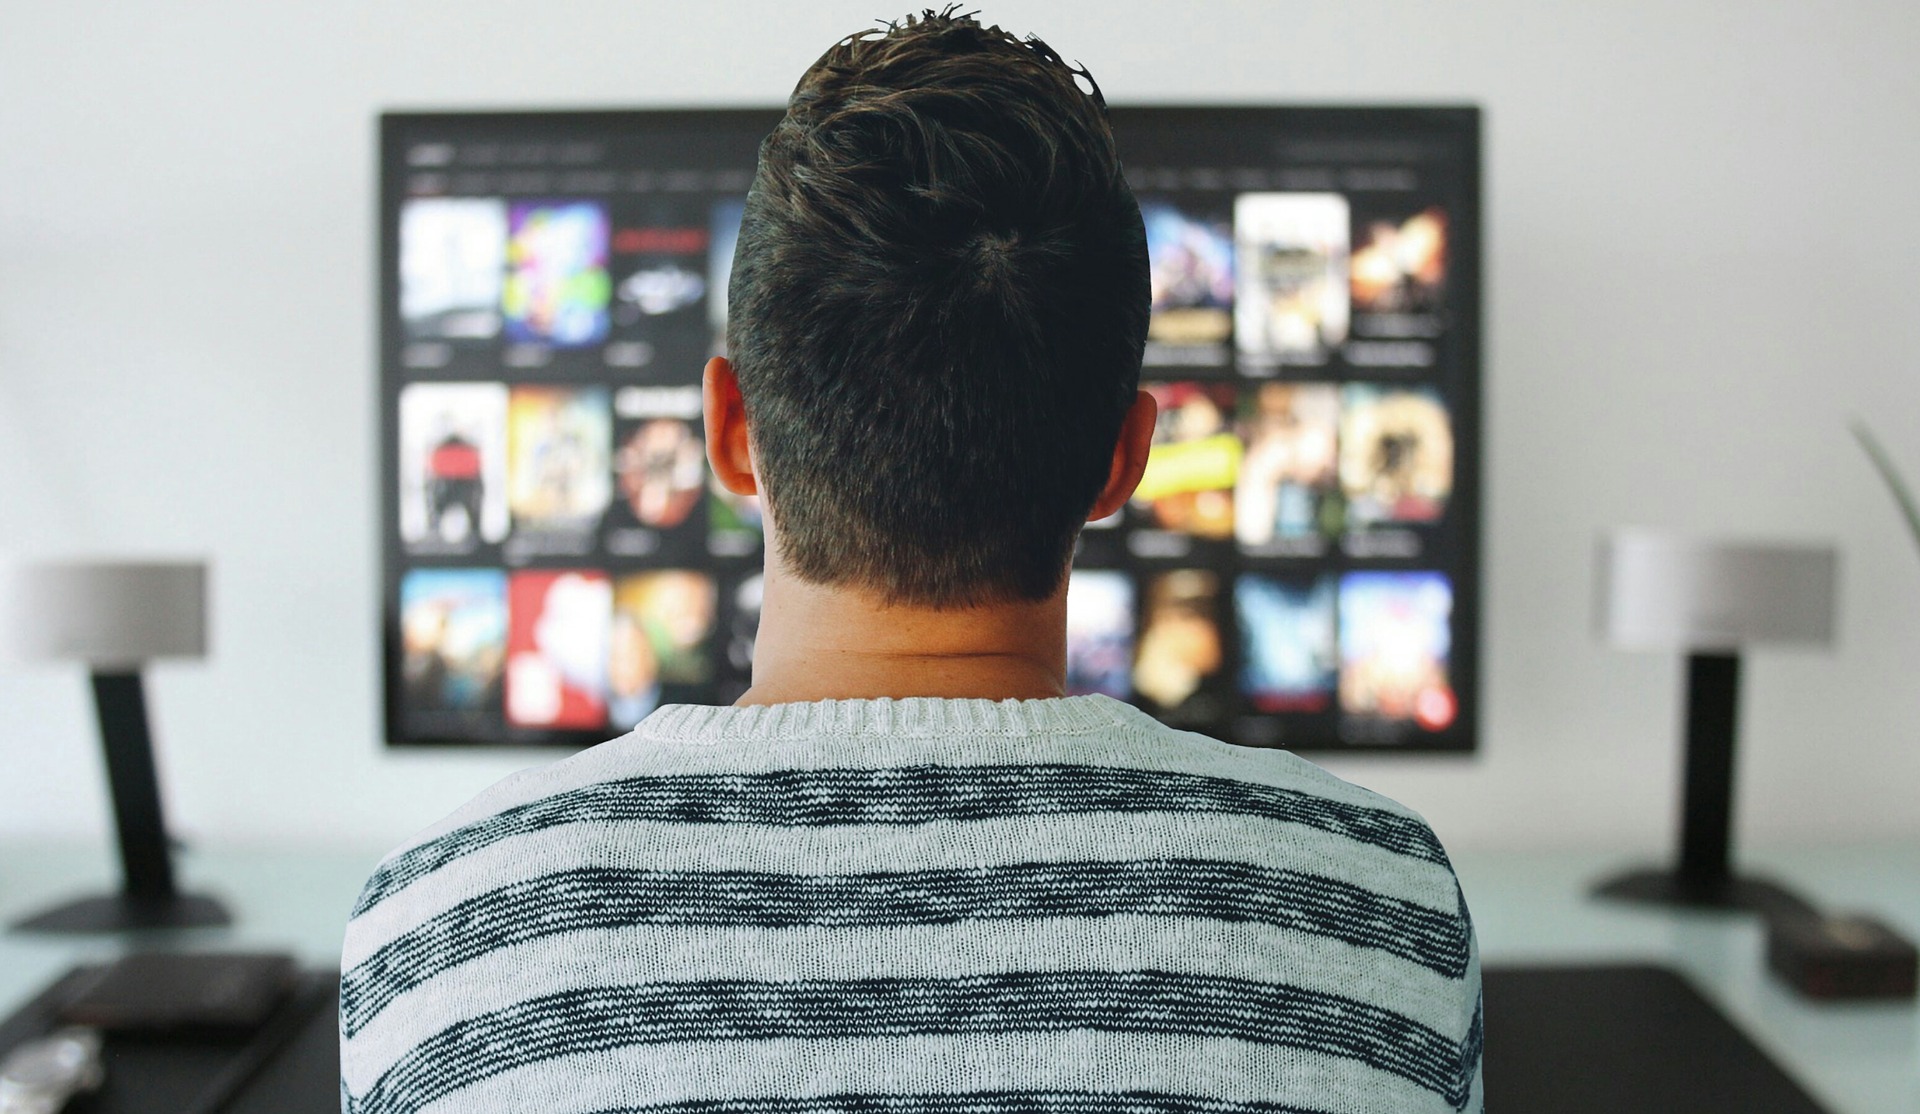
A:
1068;569;1459;745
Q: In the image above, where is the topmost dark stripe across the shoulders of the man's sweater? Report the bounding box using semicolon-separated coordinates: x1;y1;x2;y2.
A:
353;764;1446;916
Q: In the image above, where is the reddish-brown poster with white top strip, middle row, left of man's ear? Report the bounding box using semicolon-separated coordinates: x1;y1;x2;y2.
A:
612;386;707;530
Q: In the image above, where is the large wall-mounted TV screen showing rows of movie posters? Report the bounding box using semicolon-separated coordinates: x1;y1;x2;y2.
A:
378;108;1480;751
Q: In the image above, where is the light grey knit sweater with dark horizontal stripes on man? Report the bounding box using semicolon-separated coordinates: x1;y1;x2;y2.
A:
340;697;1480;1114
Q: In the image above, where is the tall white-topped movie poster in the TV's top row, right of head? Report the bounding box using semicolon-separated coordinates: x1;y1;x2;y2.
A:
1233;194;1352;371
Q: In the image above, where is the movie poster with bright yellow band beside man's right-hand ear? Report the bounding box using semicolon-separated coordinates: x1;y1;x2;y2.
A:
1133;382;1240;540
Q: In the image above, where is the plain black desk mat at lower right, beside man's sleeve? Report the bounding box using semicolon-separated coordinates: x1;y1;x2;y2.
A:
1482;966;1824;1114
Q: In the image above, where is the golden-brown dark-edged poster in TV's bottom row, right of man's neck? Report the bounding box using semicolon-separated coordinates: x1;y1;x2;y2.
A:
1133;569;1235;726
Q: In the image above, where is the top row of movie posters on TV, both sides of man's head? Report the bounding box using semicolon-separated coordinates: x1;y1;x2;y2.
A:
399;192;1450;376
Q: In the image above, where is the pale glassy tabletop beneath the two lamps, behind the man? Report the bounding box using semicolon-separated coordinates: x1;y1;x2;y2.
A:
0;845;1920;1114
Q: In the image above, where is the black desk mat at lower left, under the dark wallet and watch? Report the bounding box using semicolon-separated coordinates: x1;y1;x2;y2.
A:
0;968;340;1114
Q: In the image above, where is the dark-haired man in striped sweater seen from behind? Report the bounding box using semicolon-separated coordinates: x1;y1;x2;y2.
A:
342;13;1480;1114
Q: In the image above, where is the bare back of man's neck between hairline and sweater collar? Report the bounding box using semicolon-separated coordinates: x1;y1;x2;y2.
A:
737;561;1066;705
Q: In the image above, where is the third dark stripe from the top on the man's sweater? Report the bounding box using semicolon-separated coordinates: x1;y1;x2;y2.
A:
353;970;1480;1114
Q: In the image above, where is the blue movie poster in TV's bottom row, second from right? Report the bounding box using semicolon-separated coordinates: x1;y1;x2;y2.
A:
1233;574;1340;713
